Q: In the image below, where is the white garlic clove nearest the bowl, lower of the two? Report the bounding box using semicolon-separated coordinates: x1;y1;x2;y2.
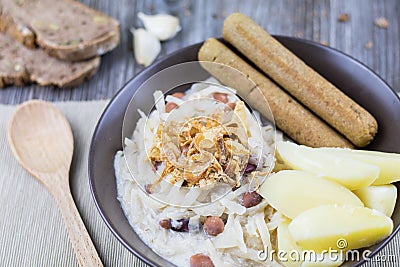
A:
131;28;161;67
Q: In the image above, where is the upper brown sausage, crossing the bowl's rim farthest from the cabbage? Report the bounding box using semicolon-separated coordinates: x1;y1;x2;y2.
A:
222;13;378;147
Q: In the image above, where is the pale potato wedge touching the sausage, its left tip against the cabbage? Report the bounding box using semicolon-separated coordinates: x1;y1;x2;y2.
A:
276;141;379;190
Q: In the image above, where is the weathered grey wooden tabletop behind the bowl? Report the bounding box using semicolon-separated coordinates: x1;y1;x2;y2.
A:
0;0;400;104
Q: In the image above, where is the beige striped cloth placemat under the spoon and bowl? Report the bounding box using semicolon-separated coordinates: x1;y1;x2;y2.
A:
0;101;400;267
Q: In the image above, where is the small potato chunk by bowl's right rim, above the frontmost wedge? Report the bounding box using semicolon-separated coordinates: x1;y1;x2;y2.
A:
354;184;397;217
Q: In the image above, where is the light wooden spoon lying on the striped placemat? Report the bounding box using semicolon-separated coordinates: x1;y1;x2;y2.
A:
8;100;103;266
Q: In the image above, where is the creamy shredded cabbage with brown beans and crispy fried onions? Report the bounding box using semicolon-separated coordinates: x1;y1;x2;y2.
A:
114;82;282;266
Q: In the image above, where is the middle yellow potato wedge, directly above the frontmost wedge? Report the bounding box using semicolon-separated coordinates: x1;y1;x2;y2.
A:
259;170;364;219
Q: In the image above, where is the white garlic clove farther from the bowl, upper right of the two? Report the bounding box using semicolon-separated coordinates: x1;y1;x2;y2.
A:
138;12;181;41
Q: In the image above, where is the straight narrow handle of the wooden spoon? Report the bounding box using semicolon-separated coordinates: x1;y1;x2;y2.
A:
52;179;103;267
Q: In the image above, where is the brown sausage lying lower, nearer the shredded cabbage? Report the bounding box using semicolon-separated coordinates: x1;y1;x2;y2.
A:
198;38;353;148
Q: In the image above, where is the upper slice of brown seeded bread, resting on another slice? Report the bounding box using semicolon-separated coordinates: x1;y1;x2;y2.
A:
0;0;120;61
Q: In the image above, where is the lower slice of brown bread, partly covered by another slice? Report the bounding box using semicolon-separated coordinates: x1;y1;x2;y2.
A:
0;33;100;87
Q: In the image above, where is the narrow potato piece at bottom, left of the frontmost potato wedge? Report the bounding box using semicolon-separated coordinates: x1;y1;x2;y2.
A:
277;220;303;267
